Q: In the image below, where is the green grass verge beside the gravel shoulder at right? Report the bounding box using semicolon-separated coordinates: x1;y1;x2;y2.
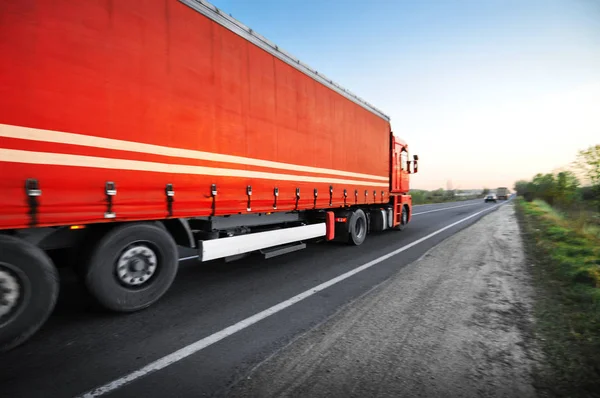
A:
515;199;600;397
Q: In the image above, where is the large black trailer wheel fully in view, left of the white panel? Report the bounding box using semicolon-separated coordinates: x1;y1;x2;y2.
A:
83;224;179;312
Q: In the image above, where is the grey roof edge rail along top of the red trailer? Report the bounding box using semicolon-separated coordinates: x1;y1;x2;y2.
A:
179;0;390;121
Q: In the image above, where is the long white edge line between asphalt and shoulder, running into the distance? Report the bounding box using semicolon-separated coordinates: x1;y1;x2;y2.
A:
82;204;502;397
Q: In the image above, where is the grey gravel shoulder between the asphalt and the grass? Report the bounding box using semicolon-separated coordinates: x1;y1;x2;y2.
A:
227;205;539;397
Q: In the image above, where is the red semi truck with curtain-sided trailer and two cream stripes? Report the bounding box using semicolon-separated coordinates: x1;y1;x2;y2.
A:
0;0;418;350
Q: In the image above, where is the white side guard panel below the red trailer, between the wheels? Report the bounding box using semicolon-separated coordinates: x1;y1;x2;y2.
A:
198;223;326;261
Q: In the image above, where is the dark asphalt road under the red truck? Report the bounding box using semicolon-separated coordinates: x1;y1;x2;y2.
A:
0;200;510;397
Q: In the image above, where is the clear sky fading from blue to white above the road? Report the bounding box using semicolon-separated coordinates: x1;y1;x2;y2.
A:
211;0;600;189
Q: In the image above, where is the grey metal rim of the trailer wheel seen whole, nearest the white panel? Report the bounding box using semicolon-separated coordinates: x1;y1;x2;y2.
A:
115;242;158;287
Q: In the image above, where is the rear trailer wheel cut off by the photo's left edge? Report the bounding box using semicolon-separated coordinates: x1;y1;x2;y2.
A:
0;235;59;351
